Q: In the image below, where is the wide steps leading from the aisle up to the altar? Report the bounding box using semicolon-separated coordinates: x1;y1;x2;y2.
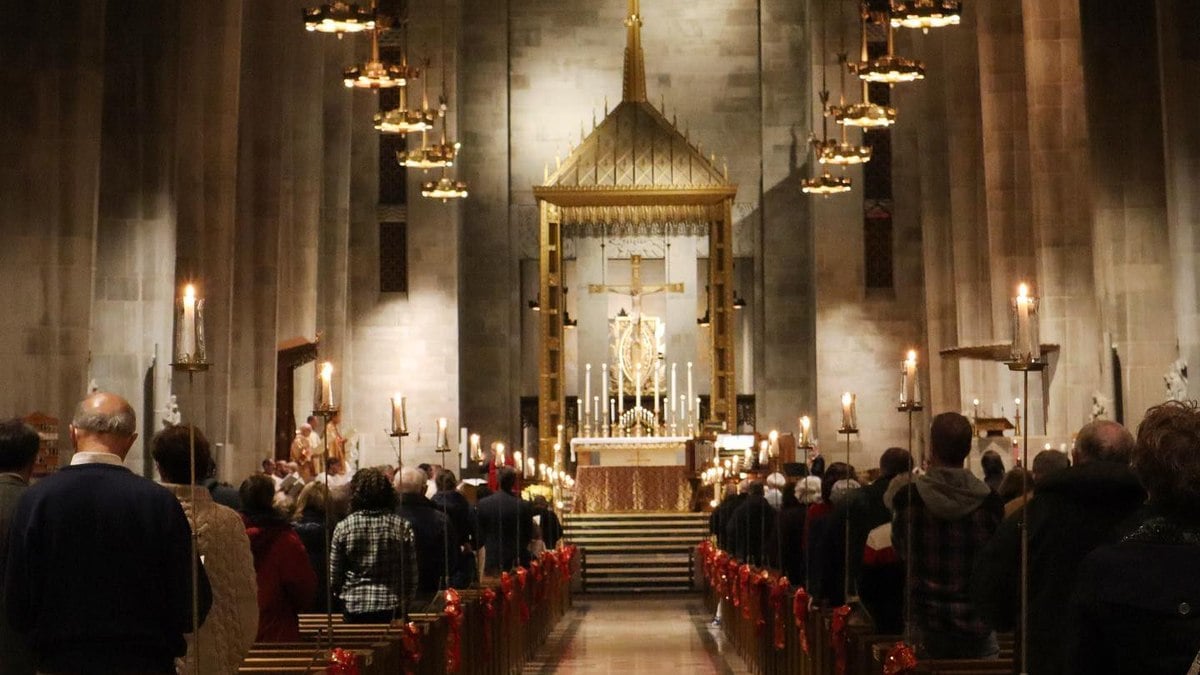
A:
563;512;708;592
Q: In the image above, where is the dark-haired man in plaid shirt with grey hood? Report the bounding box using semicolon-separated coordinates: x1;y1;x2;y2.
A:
884;412;1004;658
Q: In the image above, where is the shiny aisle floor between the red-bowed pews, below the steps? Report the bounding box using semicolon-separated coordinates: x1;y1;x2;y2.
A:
524;593;750;675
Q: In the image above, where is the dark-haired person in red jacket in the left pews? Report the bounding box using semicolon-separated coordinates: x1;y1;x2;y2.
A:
239;474;317;643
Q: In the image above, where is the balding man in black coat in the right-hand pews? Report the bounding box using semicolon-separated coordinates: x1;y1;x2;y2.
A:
971;420;1147;675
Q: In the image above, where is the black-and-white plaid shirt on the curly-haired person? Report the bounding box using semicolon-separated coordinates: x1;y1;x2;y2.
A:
330;510;416;616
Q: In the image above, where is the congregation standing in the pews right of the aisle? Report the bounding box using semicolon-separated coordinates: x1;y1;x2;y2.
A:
709;401;1200;675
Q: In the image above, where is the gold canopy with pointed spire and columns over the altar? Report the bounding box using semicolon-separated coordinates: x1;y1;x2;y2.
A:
533;0;737;447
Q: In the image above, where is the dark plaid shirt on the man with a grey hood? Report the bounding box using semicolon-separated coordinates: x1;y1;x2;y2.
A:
892;478;1004;637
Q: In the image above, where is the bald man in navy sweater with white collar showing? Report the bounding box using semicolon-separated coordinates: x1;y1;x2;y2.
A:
5;392;211;674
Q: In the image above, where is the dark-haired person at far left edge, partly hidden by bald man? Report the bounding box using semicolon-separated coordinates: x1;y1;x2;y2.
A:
0;419;41;675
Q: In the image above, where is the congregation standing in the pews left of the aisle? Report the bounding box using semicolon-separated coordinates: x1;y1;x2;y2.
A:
0;393;560;675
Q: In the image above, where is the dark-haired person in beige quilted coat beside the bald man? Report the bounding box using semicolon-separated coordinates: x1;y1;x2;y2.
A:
150;425;258;674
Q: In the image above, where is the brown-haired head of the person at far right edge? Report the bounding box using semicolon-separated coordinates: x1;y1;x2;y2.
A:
1133;401;1200;520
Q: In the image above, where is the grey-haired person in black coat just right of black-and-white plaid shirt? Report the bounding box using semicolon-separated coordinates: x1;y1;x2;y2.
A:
396;467;461;599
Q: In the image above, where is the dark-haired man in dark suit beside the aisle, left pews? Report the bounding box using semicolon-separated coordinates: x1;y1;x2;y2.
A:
475;466;533;574
